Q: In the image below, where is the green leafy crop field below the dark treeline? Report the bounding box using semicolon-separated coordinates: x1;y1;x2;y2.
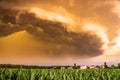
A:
0;68;120;80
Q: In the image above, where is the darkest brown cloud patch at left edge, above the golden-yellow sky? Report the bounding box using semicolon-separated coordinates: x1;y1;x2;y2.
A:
0;7;23;37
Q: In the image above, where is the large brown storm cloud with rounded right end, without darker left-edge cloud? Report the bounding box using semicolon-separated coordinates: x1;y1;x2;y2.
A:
17;12;103;57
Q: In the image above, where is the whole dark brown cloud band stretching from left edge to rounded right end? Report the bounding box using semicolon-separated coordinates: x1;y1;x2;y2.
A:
0;6;103;57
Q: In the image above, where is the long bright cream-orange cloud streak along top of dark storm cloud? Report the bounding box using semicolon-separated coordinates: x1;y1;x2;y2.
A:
30;7;74;24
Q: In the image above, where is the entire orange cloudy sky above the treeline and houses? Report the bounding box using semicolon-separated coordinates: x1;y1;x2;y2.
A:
0;0;120;65
